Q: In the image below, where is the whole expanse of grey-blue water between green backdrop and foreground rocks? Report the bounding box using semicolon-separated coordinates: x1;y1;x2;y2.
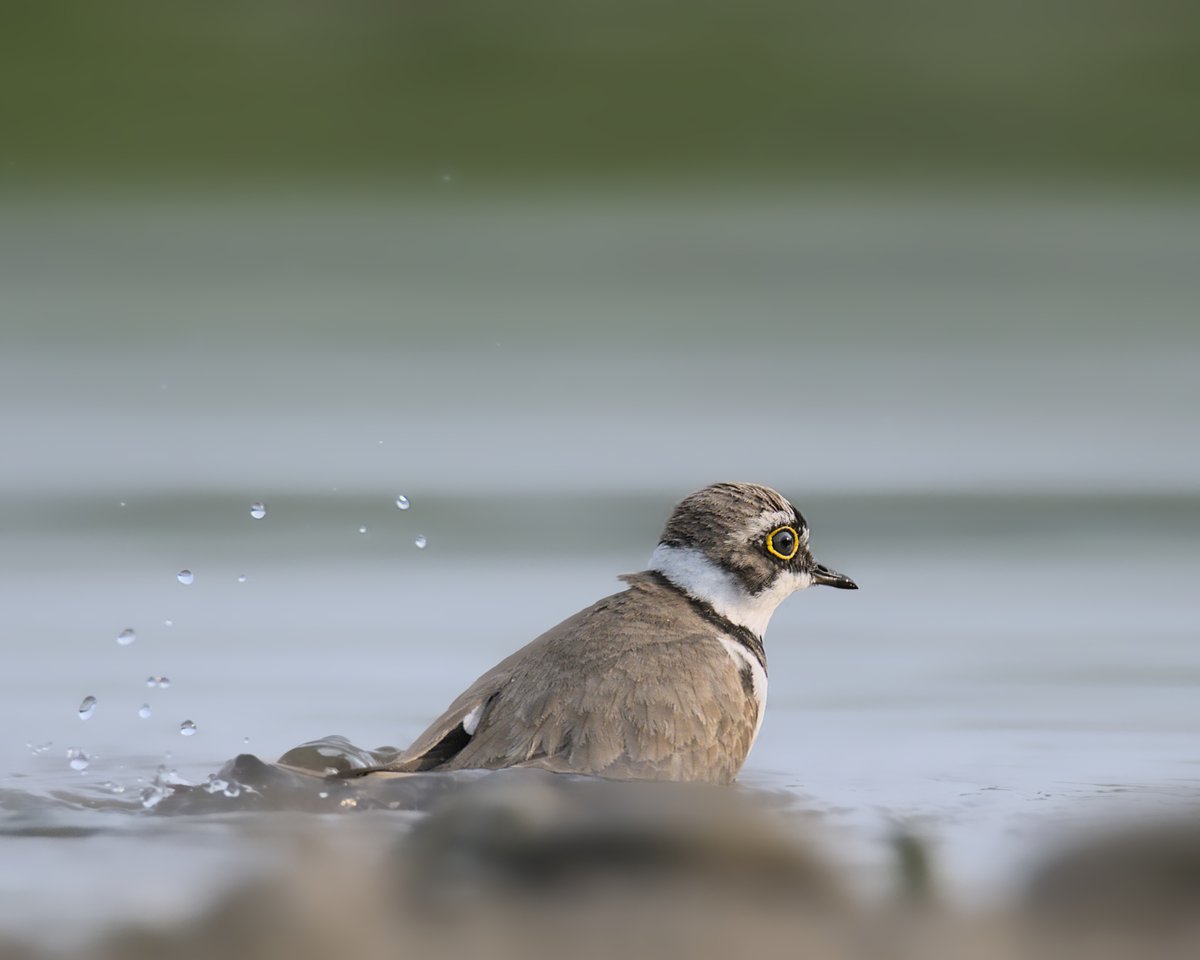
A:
0;190;1200;941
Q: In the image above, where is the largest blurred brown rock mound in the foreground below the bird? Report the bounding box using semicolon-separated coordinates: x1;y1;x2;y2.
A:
87;770;856;960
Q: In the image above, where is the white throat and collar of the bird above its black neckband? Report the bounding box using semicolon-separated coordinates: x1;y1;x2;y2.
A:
649;544;812;638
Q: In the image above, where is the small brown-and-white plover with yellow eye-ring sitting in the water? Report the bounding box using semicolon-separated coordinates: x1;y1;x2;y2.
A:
352;482;858;784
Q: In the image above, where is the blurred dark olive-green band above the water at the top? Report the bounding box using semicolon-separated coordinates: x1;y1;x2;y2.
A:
0;0;1200;184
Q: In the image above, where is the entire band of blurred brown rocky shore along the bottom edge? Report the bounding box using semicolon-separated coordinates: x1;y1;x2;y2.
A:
7;762;1200;960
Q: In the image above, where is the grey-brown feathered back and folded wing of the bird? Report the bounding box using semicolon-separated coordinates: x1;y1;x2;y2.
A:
350;577;757;781
